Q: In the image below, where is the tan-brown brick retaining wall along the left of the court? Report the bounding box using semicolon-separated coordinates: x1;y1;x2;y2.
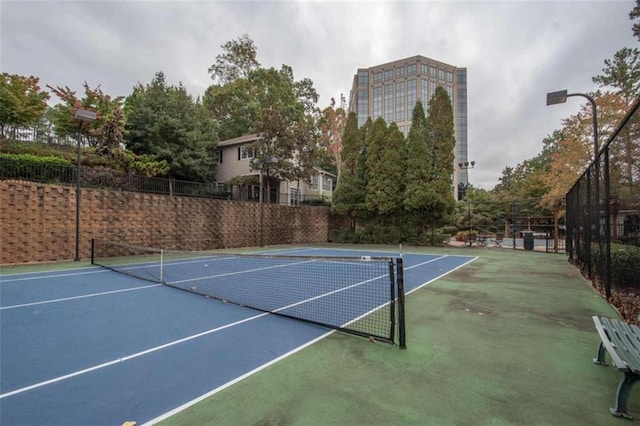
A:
0;180;329;264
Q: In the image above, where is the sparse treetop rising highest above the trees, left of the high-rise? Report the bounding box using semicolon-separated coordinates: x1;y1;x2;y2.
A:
209;34;260;86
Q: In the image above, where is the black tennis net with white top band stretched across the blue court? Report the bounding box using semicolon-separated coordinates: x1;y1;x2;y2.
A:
91;239;405;348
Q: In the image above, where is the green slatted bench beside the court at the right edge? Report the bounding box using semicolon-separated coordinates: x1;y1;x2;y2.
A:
592;316;640;420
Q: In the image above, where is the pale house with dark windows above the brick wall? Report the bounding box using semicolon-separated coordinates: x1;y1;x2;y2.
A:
216;134;336;205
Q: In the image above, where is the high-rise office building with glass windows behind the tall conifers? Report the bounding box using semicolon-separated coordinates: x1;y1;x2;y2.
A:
349;55;469;199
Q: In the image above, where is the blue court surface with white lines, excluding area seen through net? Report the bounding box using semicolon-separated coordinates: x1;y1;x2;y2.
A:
0;248;474;425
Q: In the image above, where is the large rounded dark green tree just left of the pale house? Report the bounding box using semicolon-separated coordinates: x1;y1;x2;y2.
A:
125;72;217;182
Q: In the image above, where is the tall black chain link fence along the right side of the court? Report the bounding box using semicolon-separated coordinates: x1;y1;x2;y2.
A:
566;99;640;323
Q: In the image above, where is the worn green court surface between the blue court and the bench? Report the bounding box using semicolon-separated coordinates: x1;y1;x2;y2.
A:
156;247;640;425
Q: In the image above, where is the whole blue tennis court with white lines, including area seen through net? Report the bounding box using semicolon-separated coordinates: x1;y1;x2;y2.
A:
0;248;475;425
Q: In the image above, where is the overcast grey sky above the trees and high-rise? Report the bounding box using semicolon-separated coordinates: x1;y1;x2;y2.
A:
0;0;638;189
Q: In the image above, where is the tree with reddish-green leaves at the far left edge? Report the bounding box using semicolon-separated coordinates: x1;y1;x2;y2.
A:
0;72;49;137
